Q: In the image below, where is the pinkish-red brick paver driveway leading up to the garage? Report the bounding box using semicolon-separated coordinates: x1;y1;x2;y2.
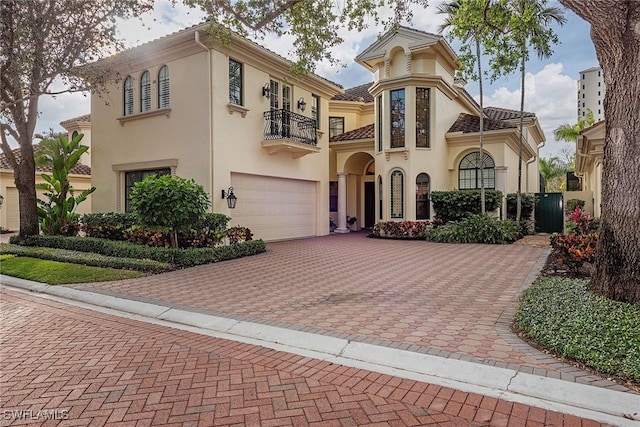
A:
73;233;553;369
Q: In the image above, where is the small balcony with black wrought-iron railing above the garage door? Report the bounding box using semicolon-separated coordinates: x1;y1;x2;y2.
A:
262;110;320;159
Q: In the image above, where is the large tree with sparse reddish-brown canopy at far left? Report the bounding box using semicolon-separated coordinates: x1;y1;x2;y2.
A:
0;0;154;237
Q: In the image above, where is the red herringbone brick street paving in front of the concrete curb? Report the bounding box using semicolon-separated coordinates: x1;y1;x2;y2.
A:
0;289;600;426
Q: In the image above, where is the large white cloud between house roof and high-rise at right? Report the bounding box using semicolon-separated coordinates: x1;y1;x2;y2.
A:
476;63;577;157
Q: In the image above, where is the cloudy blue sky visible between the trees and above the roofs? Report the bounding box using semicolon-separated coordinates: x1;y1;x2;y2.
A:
36;0;598;157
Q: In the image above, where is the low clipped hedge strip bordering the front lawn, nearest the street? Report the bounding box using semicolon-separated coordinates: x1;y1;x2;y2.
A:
0;243;173;273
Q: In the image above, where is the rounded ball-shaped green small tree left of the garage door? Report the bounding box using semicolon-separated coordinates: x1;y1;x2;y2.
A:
129;175;210;248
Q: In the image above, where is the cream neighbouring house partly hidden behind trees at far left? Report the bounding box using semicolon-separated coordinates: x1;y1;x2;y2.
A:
0;114;91;231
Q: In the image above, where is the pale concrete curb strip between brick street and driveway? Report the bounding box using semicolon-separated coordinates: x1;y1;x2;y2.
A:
0;275;640;427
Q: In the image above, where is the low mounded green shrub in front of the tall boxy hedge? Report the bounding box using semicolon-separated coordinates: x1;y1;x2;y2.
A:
427;214;520;244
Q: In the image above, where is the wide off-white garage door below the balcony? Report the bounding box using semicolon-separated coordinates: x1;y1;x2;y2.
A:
230;173;317;241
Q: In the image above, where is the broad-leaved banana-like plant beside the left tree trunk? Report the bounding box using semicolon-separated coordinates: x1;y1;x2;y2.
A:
35;134;96;236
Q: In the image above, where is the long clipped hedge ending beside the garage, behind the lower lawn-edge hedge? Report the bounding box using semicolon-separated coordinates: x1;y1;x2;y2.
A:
11;236;266;267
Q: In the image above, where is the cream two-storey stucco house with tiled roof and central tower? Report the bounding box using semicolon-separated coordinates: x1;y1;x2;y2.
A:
91;24;544;240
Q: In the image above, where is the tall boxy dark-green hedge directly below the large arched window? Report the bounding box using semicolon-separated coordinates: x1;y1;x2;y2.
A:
431;190;502;222
